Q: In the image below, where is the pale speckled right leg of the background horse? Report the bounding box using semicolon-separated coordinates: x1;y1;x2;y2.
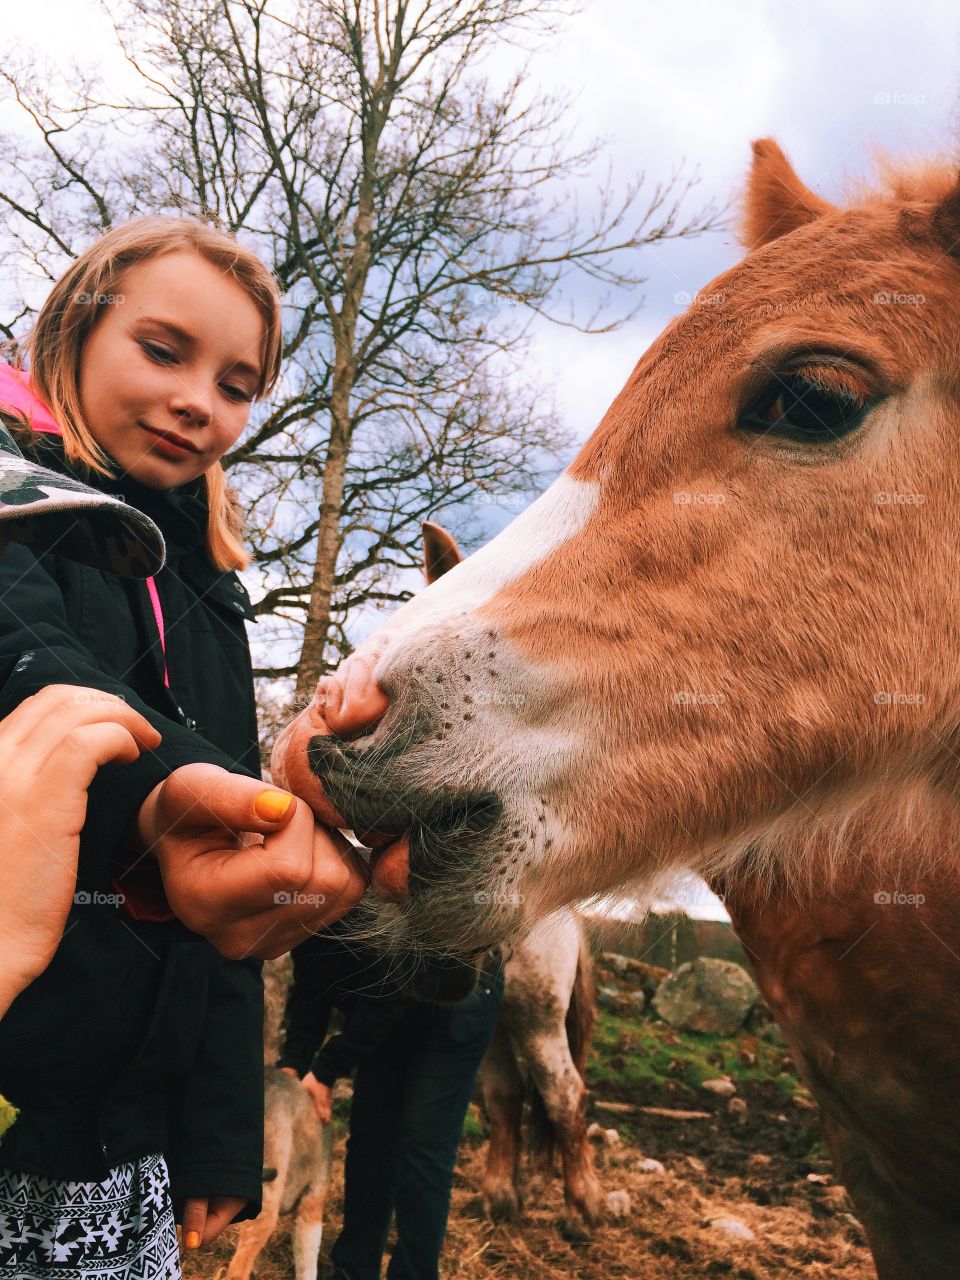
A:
524;1027;604;1225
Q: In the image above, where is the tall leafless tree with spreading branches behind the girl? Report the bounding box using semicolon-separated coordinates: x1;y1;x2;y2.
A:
0;0;718;695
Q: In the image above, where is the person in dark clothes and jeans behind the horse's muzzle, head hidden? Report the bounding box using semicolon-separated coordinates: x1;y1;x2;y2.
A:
279;922;503;1280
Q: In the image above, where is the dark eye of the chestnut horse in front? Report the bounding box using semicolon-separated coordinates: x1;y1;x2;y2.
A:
737;374;872;444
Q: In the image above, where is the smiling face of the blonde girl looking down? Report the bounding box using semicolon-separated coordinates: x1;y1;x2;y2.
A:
79;250;266;489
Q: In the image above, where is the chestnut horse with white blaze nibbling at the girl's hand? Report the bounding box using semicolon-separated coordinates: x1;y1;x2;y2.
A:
278;141;960;1280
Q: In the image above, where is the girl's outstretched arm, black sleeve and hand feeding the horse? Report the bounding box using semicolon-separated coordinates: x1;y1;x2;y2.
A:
0;545;365;957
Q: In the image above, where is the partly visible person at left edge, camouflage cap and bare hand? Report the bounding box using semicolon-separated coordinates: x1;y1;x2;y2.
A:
0;426;164;1018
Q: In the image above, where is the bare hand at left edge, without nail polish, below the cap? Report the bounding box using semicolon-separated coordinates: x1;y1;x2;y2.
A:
0;685;160;1015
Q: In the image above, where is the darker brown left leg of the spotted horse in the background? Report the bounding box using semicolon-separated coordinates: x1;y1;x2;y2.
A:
480;1023;524;1220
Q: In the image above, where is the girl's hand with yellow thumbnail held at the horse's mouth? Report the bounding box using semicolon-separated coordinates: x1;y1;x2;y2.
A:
140;764;367;960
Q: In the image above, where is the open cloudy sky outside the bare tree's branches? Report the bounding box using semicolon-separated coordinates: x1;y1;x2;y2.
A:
7;0;960;914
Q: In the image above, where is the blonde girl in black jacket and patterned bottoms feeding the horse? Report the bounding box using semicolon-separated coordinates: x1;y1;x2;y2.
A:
0;218;365;1280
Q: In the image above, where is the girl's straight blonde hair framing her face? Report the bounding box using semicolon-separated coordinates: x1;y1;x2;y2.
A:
8;216;283;570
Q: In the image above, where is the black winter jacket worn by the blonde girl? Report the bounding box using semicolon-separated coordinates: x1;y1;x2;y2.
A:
0;436;262;1216
